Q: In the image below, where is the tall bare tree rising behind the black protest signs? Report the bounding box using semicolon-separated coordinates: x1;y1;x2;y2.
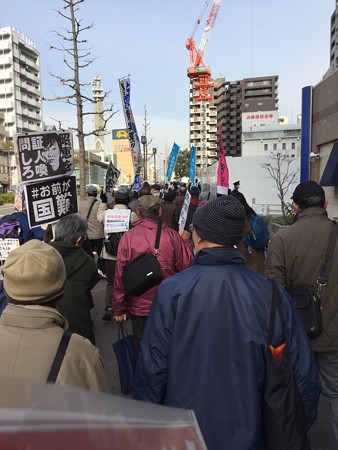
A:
43;0;115;199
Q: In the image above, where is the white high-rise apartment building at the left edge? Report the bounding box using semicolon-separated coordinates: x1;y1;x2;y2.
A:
0;27;42;139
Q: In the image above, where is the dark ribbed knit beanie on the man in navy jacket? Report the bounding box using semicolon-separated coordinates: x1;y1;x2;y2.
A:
192;195;245;245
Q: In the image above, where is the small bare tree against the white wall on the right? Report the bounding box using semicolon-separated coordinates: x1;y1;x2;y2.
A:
262;153;299;219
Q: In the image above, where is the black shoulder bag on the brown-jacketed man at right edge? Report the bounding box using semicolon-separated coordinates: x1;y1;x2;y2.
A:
288;221;338;339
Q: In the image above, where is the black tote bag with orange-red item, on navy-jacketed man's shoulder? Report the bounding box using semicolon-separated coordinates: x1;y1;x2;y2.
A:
262;280;309;450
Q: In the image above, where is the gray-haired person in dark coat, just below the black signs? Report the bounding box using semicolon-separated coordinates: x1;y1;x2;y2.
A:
50;214;100;344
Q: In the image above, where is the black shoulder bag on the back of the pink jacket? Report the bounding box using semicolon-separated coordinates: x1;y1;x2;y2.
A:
122;220;163;297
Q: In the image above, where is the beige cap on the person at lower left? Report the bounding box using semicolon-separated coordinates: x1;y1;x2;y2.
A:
2;239;66;304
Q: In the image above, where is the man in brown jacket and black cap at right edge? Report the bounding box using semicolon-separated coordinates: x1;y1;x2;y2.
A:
267;180;338;445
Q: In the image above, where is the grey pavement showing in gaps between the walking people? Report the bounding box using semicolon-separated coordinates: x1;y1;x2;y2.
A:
92;278;337;450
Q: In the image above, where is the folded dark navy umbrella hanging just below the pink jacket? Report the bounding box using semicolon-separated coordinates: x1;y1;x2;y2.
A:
113;322;137;394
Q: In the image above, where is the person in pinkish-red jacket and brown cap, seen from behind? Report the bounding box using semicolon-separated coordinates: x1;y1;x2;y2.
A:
113;195;193;349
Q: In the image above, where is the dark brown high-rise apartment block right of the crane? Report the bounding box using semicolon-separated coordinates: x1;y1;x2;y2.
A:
214;75;278;156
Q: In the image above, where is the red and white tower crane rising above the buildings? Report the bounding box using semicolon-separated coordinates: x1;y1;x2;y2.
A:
186;0;222;179
